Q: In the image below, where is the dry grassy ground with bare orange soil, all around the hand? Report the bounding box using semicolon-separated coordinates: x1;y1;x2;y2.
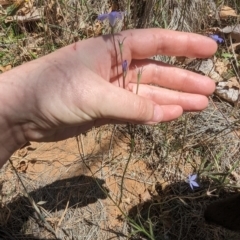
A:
0;0;240;240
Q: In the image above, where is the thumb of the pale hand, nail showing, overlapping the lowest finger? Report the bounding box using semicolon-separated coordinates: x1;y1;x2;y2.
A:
87;80;182;123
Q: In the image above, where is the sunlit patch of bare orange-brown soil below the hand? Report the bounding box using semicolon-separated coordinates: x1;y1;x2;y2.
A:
1;124;163;238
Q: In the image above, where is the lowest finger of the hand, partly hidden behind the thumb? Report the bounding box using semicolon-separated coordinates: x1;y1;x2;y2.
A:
129;84;208;111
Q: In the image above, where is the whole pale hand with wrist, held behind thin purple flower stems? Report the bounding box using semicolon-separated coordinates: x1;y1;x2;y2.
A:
0;29;217;167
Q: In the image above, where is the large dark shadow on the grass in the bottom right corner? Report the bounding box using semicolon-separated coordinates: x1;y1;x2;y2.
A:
129;182;240;240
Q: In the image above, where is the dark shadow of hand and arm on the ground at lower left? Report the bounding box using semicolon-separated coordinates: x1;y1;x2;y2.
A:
0;175;108;240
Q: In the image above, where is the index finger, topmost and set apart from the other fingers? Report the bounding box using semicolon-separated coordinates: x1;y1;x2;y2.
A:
118;28;217;59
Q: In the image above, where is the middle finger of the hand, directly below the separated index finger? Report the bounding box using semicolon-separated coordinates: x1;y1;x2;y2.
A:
127;60;215;95
